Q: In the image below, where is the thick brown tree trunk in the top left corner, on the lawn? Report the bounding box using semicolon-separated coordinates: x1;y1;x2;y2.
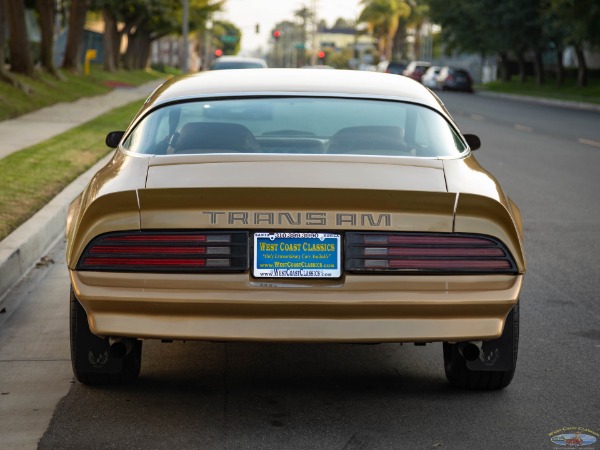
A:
5;0;34;76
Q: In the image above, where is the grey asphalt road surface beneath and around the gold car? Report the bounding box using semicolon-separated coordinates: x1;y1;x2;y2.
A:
0;93;600;450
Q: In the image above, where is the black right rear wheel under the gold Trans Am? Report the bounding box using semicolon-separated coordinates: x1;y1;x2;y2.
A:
444;303;519;390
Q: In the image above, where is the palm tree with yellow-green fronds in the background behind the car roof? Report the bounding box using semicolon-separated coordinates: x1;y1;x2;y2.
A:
358;0;411;60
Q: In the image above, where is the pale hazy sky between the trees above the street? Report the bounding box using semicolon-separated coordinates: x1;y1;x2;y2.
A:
215;0;362;55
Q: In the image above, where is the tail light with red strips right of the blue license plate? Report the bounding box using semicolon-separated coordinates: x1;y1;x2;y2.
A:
346;233;517;273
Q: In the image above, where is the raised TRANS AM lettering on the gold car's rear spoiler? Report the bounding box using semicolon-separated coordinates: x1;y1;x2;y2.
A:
202;211;392;228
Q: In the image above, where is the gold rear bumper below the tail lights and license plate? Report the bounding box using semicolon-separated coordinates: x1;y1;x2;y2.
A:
71;271;523;343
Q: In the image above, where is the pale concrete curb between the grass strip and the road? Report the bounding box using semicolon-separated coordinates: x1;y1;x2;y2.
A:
0;152;114;304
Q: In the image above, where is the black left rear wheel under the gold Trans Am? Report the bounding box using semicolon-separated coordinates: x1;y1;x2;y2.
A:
69;289;142;385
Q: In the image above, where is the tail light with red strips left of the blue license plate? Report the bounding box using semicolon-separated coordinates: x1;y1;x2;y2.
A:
77;231;248;273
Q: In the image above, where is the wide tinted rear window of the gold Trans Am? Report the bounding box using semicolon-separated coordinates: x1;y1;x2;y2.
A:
123;97;466;157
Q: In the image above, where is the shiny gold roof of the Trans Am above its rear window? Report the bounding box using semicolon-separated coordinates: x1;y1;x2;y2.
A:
143;69;447;116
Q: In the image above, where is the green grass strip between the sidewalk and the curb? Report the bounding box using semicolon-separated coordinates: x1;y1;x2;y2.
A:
0;100;144;240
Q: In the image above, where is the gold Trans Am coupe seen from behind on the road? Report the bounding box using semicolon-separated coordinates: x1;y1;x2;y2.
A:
66;69;525;389
